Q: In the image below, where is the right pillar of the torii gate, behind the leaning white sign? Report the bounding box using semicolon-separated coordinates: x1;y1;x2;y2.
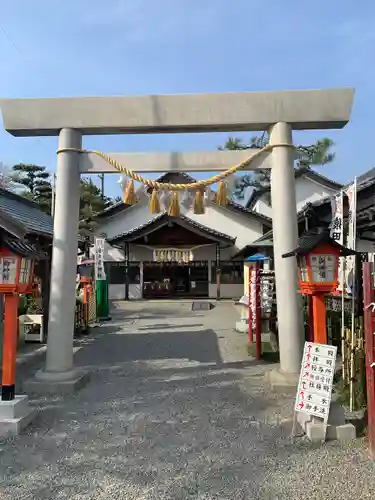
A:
270;123;304;374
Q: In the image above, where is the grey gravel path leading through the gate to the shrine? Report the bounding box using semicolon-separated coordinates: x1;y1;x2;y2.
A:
0;302;375;500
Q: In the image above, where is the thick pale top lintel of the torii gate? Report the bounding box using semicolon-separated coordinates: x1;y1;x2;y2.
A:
0;88;354;137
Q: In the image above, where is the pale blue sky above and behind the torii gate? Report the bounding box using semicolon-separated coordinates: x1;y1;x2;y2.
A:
0;0;375;199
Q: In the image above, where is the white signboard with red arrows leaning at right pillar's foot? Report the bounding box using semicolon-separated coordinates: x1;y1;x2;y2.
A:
295;342;337;422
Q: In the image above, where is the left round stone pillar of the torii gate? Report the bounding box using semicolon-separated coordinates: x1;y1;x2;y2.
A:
36;129;82;382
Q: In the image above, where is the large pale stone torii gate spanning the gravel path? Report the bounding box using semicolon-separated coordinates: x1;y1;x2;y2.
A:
0;88;354;392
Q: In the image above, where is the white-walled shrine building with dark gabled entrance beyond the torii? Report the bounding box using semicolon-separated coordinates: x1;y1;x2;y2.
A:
91;173;272;300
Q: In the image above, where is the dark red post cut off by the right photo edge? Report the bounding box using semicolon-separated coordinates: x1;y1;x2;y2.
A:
363;262;375;460
